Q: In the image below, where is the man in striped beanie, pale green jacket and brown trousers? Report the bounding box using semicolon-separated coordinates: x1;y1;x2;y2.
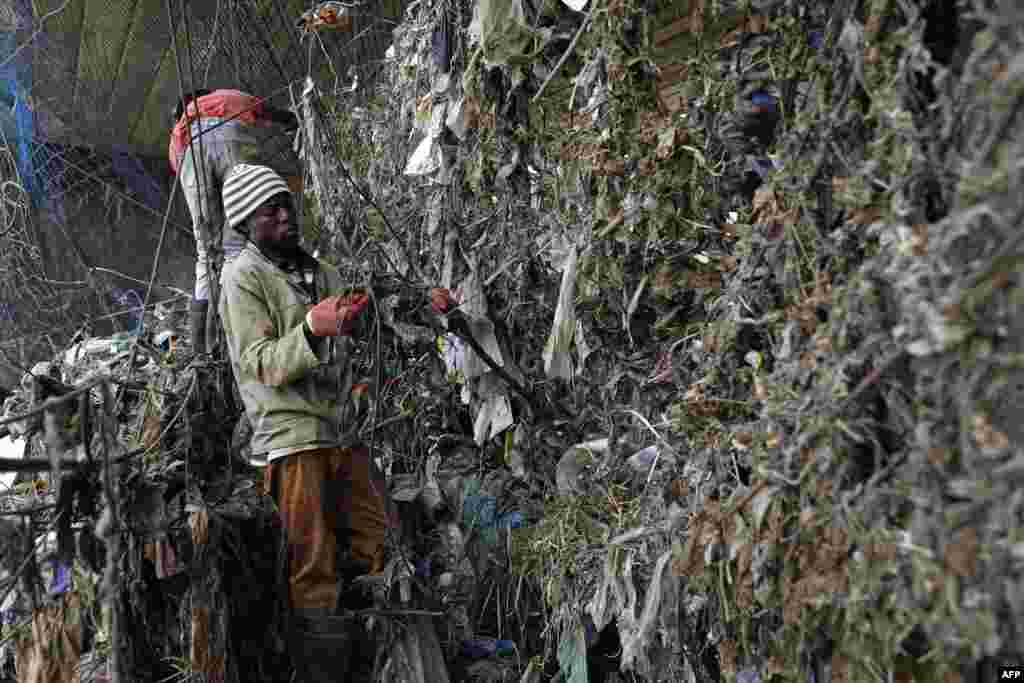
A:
219;164;388;681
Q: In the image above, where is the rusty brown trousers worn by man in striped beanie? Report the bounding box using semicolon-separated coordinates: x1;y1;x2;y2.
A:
264;447;389;610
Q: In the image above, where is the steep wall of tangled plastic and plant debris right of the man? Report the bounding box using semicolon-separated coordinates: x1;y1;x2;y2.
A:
307;0;1024;681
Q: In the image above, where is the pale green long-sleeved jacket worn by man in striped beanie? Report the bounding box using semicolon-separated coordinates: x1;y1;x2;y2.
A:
220;244;351;465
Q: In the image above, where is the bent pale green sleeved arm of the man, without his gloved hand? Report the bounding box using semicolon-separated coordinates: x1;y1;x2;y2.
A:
222;272;319;386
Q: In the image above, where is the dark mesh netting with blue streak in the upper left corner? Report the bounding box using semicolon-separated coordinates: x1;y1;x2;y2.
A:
0;0;403;368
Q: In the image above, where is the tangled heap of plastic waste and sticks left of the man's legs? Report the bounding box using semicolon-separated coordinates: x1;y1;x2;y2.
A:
0;299;292;683
